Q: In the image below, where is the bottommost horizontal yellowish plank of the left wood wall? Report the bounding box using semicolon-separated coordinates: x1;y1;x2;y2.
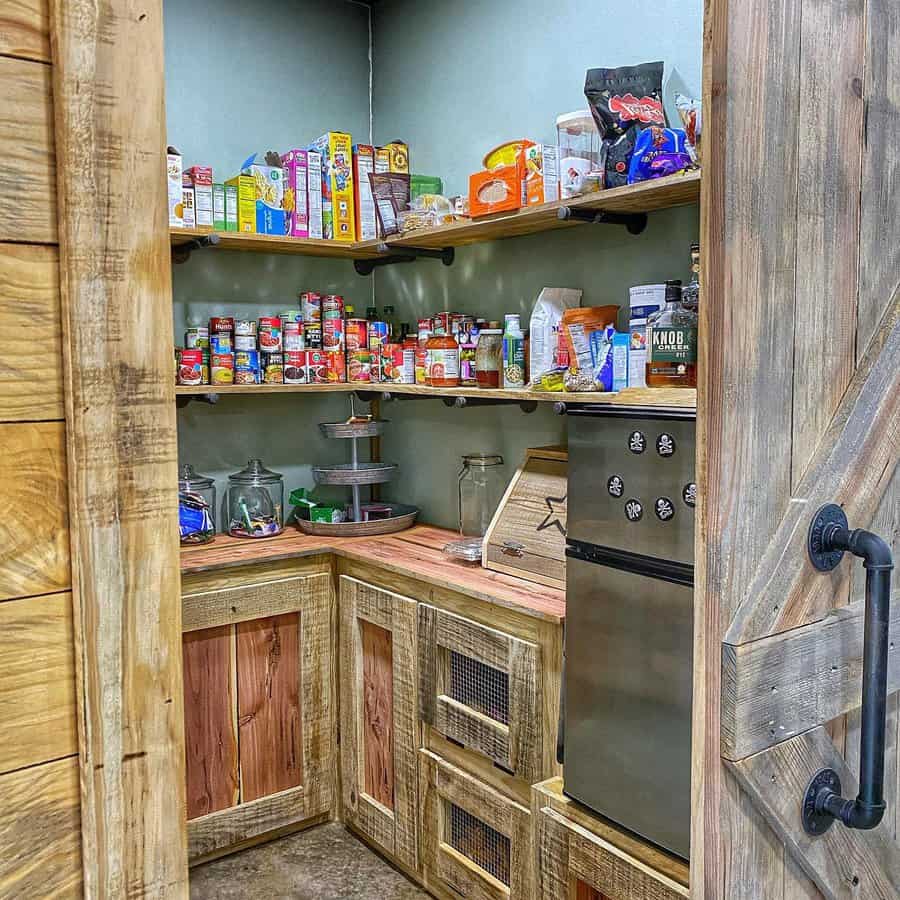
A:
0;757;82;900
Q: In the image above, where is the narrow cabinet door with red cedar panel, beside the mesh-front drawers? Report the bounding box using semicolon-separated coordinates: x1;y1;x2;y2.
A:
340;575;419;870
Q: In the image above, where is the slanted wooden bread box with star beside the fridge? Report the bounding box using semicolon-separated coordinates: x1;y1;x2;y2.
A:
481;447;569;590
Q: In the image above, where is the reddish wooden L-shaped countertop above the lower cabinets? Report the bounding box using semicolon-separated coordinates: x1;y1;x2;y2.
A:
181;525;566;622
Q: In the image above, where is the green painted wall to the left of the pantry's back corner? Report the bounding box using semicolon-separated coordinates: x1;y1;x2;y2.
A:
164;0;373;523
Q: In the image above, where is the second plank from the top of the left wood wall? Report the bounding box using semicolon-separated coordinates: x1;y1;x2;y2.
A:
0;56;57;244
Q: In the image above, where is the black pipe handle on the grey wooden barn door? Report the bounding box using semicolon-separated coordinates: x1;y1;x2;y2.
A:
802;503;894;835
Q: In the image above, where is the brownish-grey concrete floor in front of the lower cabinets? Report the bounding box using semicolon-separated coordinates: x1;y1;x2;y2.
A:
191;823;429;900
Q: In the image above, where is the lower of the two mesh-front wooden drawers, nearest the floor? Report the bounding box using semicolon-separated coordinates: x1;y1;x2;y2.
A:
419;750;533;900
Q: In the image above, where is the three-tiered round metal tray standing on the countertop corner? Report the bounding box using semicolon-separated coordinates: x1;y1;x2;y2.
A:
297;397;419;537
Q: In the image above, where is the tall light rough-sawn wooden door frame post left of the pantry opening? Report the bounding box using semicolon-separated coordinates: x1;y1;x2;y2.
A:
50;0;188;898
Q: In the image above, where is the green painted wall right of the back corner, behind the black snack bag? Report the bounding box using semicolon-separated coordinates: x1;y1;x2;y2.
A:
373;0;703;526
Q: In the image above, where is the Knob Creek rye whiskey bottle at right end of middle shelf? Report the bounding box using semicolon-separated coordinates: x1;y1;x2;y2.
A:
646;279;697;387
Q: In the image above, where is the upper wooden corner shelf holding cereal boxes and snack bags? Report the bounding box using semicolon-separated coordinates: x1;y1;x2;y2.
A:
170;171;700;260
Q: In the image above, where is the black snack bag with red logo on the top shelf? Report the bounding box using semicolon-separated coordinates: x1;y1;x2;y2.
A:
584;62;666;188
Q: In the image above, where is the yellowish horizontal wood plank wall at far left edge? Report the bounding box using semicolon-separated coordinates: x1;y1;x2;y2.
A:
0;0;82;900
